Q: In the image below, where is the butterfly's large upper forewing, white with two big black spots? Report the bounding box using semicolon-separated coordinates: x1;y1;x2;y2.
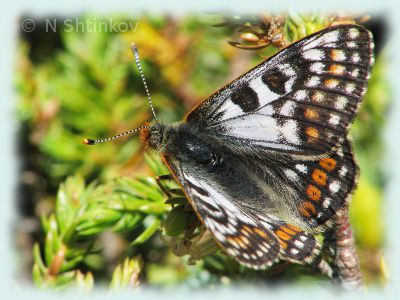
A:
186;25;373;156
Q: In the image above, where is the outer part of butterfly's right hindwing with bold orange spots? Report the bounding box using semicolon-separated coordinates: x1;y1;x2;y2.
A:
283;140;358;228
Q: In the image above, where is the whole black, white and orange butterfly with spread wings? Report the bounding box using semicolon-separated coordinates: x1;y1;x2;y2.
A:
87;25;374;269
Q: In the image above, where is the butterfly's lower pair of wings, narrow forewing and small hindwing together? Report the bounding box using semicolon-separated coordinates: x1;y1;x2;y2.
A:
177;171;319;269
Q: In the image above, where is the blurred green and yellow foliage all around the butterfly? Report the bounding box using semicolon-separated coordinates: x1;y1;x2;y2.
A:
15;13;391;290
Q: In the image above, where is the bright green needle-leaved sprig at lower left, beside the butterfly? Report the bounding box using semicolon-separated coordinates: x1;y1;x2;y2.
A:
33;173;169;288
